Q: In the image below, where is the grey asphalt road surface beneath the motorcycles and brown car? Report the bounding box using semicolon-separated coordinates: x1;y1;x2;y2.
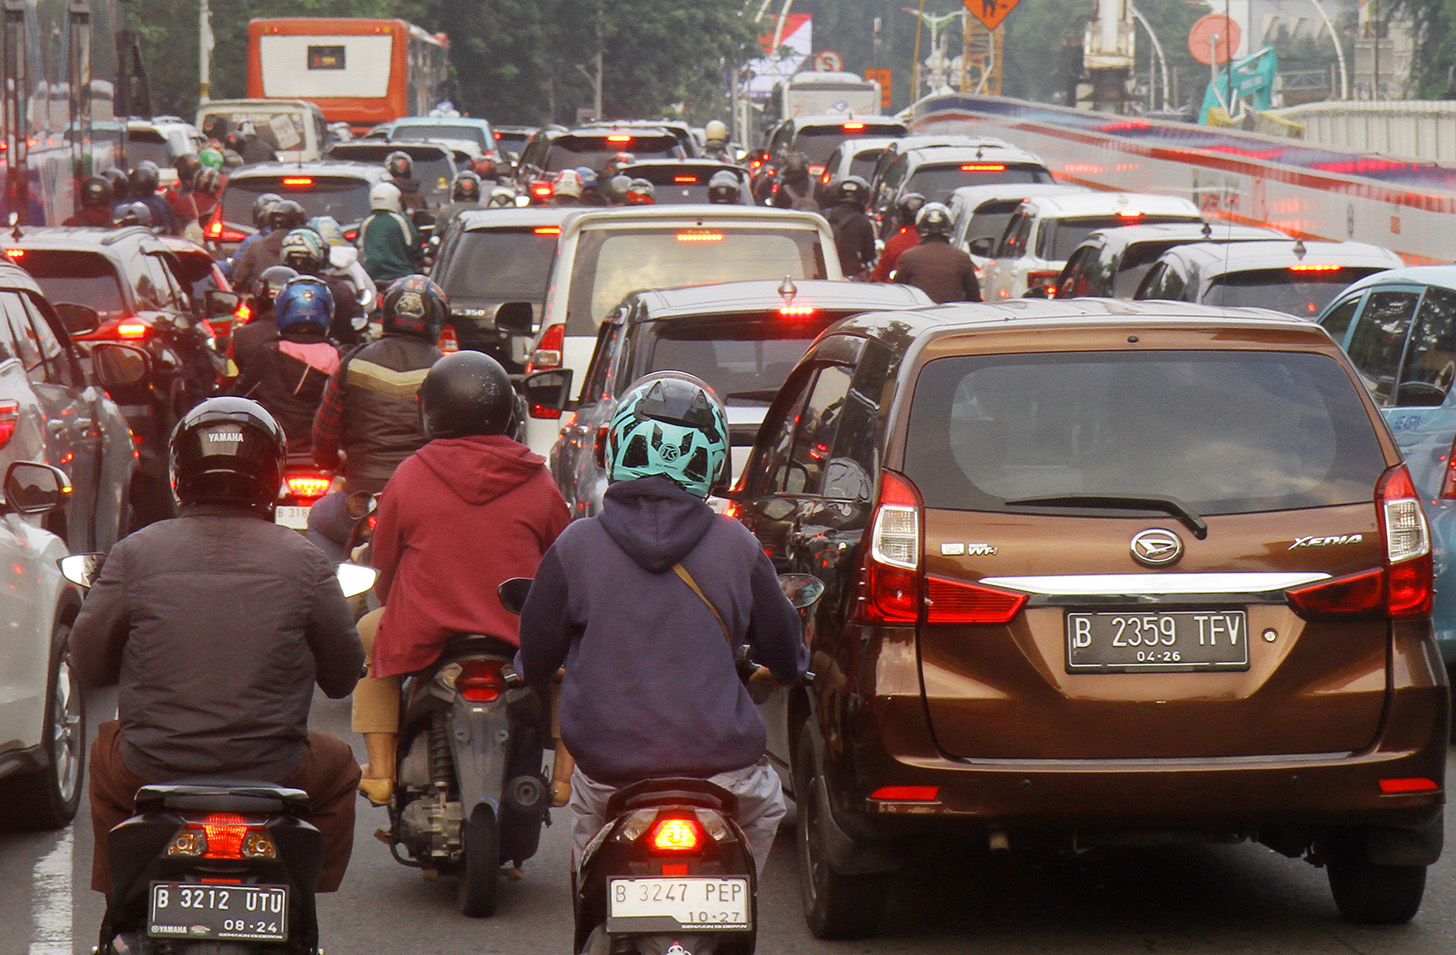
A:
8;693;1456;955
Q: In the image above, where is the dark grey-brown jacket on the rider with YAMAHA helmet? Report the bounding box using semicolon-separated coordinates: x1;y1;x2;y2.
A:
71;505;364;782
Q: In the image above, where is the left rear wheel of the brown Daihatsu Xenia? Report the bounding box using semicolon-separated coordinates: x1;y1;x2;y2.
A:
794;722;890;939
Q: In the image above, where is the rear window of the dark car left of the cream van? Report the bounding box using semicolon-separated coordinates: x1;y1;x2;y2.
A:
437;226;556;303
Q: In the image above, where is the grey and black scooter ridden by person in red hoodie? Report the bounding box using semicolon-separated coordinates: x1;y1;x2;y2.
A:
380;623;550;919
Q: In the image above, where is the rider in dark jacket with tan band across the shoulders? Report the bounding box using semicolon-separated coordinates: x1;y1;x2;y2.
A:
313;275;439;494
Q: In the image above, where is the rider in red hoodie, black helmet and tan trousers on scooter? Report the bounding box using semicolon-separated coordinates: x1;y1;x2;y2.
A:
354;351;571;804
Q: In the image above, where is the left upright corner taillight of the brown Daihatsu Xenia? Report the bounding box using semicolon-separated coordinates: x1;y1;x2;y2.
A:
860;470;920;623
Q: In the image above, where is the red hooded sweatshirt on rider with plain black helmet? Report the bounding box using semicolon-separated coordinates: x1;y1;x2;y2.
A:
371;435;571;677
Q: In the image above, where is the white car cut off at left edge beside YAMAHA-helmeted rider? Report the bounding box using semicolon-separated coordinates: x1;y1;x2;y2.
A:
0;461;86;828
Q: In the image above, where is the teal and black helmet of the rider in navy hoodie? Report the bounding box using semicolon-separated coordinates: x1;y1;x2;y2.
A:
606;371;728;498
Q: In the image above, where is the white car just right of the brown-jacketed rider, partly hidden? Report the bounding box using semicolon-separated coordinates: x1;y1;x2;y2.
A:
981;192;1203;301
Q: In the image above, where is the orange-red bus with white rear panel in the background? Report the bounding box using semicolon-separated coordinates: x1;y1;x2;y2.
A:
248;16;450;132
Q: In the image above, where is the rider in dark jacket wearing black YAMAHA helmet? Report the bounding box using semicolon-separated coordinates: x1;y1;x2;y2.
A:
70;397;364;892
